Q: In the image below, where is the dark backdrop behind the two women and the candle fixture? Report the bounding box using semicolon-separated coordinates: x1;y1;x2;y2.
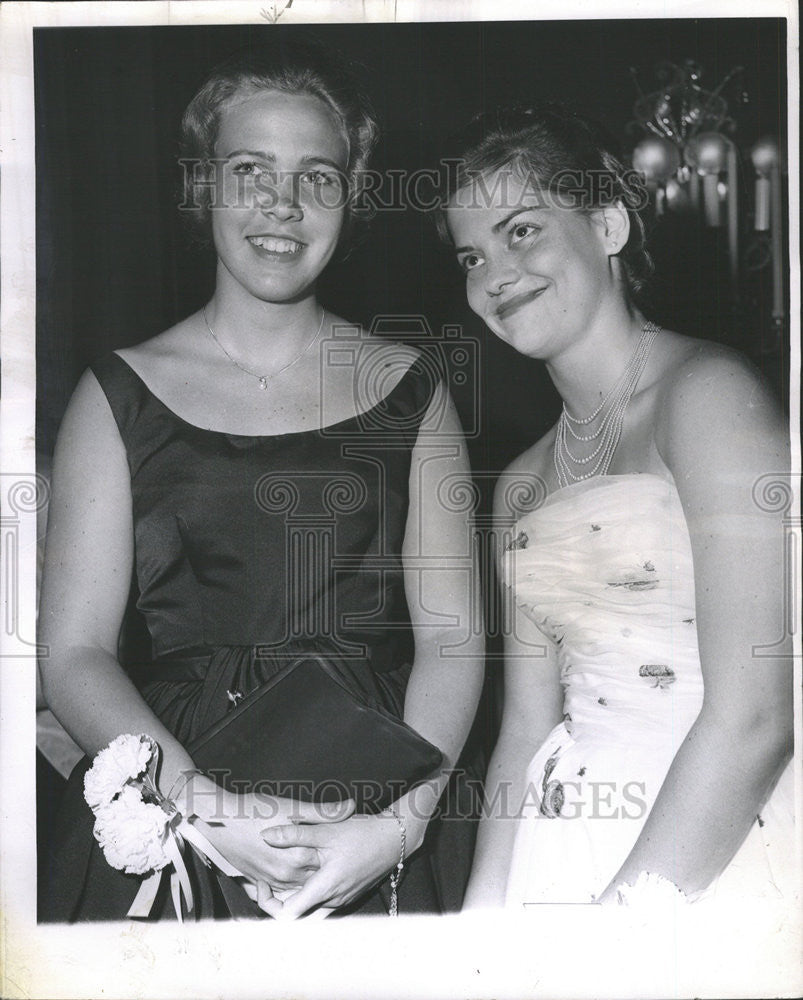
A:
35;19;788;780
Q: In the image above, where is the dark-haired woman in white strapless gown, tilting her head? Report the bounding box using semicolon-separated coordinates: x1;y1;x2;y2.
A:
440;107;795;908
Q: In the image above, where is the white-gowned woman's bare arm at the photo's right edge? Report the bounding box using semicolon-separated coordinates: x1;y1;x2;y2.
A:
601;351;793;902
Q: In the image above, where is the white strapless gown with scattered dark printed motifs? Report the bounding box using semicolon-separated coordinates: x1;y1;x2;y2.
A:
504;473;796;907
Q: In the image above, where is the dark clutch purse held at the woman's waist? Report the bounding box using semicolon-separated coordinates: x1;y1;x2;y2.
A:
187;655;443;812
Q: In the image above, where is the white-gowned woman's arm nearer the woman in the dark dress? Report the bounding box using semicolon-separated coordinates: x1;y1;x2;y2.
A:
464;590;563;909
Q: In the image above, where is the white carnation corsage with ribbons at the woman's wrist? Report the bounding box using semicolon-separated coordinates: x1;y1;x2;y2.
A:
84;733;241;920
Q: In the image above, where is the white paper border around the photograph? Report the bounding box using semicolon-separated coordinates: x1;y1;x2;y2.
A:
0;0;803;1000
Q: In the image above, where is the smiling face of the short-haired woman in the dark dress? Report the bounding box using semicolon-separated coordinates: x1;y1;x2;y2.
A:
211;90;348;302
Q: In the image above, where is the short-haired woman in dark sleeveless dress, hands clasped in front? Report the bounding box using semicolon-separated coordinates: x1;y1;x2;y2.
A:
40;44;481;920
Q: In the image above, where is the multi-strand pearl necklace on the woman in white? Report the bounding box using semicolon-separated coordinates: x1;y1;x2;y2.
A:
553;323;660;488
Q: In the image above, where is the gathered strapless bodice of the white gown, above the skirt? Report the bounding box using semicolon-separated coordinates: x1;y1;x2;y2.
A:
505;474;703;746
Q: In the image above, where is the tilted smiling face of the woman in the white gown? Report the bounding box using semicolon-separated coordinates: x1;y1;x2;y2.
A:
446;169;618;360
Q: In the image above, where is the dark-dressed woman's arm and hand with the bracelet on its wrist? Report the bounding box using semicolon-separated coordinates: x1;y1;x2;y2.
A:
266;387;484;916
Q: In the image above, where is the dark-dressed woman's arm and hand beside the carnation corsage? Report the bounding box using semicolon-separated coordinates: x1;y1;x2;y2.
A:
39;373;343;904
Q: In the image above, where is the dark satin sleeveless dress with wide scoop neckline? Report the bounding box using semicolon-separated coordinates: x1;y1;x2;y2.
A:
39;354;473;921
